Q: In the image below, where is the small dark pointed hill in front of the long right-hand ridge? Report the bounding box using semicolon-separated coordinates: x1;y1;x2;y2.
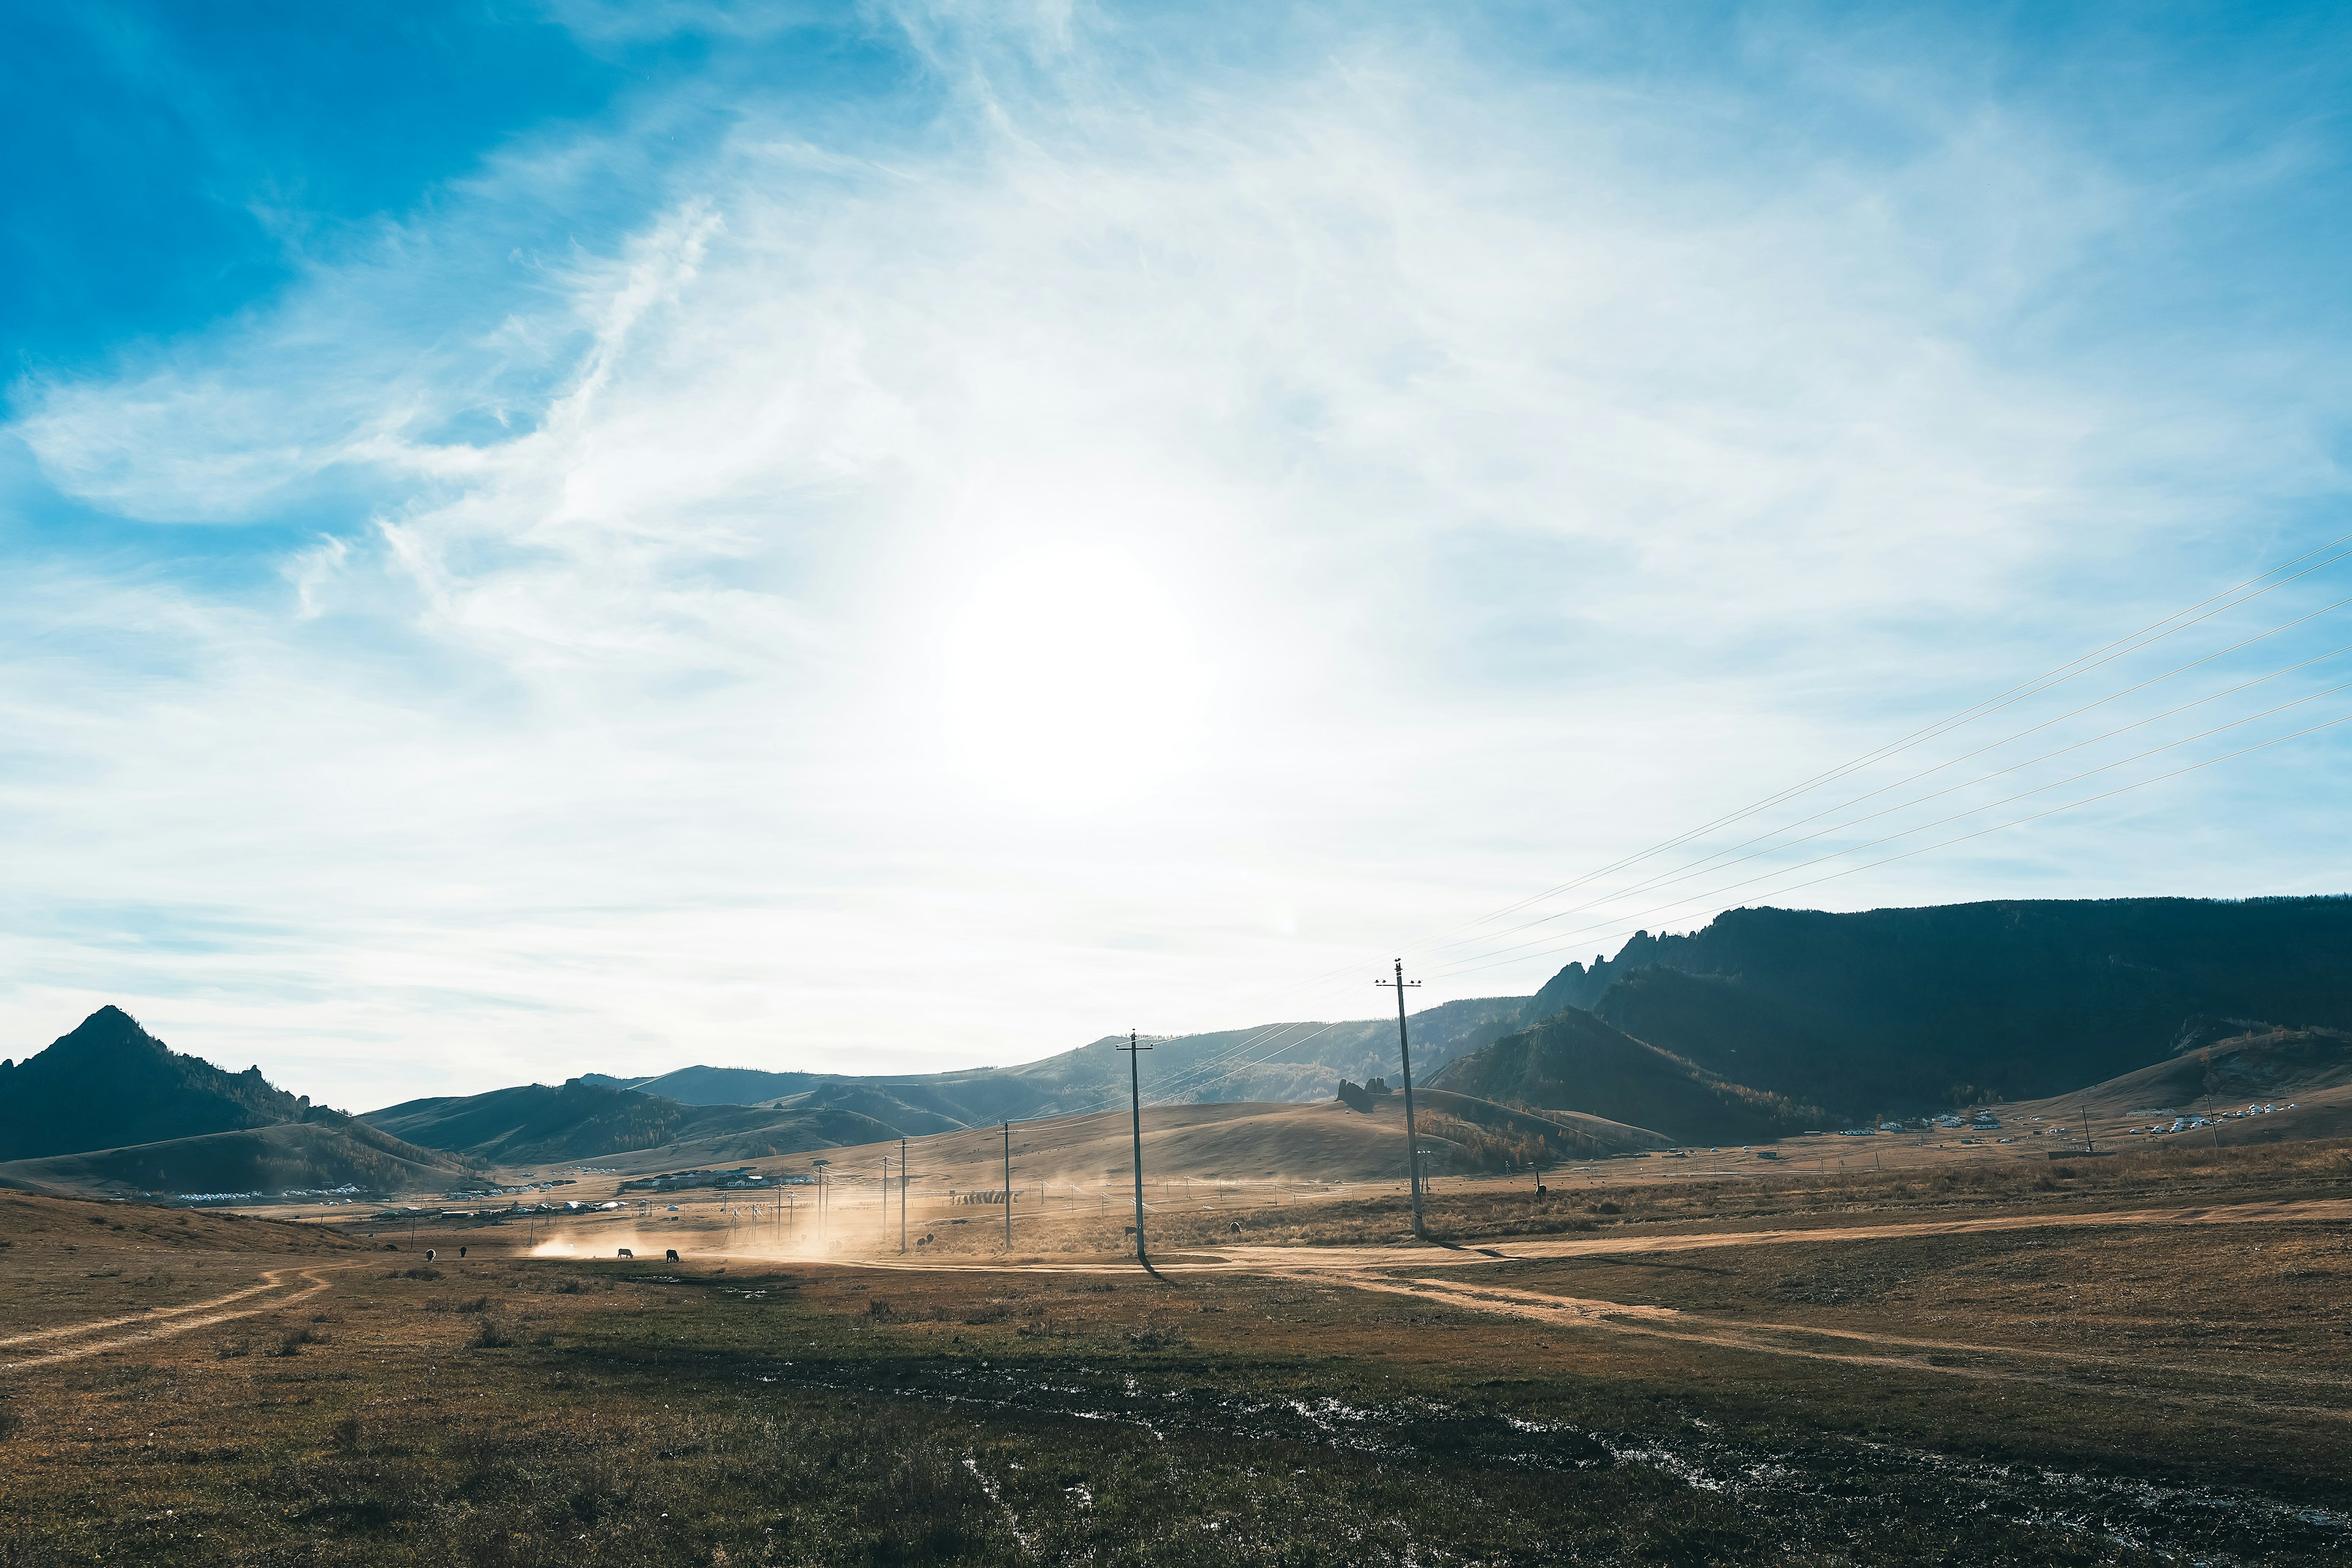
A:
1430;1006;1820;1142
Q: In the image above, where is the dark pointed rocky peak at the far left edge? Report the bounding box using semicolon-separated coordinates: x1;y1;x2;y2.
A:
0;1006;311;1161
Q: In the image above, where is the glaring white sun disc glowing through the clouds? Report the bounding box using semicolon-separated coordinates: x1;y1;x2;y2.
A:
946;552;1204;806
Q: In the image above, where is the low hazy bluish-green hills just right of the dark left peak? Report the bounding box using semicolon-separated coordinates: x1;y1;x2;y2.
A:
364;1079;899;1166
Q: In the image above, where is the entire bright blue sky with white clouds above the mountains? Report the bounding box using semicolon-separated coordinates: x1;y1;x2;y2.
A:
0;0;2352;1110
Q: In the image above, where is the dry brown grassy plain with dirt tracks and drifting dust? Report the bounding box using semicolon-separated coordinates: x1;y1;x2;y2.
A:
0;1145;2352;1568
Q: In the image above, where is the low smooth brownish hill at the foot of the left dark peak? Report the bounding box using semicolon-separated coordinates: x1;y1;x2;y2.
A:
0;1110;478;1194
